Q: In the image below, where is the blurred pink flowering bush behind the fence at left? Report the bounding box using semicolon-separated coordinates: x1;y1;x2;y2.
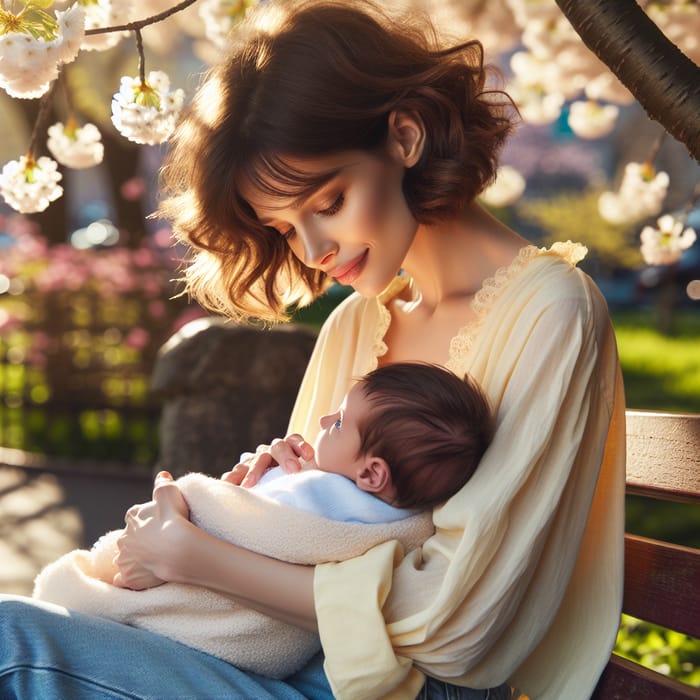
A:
0;215;198;463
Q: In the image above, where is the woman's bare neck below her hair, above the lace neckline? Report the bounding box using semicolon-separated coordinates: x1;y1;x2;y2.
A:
403;204;527;313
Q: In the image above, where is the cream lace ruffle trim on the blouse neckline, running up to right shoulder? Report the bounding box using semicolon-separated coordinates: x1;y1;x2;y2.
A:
447;241;588;371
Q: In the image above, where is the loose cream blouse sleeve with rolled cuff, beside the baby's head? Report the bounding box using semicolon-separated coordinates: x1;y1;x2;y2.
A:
314;278;624;698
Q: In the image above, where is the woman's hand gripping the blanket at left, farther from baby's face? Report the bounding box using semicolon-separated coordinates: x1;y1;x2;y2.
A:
114;472;190;590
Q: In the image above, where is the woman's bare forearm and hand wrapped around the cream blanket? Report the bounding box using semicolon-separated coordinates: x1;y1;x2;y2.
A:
115;472;317;631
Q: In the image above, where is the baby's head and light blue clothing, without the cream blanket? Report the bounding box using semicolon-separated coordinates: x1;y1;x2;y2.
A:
243;363;493;522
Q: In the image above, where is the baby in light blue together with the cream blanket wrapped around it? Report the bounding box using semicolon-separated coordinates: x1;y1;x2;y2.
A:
34;363;493;678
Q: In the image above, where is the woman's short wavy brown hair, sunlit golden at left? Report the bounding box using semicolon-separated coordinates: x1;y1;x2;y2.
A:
160;0;513;321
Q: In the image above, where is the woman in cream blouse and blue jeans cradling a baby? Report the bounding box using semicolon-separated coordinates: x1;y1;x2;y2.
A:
0;2;624;699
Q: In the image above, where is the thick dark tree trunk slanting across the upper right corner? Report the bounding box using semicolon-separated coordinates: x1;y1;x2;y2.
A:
556;0;700;161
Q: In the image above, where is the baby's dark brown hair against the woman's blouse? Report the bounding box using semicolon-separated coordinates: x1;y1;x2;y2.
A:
358;362;494;508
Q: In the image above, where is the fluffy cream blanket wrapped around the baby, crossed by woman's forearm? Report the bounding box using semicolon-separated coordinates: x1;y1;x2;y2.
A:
33;474;433;678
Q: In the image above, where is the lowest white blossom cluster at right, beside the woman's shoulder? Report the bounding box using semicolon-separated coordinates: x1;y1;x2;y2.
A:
598;163;669;225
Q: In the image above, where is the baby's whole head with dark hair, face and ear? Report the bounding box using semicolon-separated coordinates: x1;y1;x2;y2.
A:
316;362;493;508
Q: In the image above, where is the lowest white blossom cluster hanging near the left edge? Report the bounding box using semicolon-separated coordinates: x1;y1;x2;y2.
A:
0;155;63;214
